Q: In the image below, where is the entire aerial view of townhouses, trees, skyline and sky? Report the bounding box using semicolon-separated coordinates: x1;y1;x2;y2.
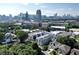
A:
0;3;79;55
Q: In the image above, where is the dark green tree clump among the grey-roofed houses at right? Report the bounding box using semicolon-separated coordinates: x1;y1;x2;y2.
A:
57;35;79;49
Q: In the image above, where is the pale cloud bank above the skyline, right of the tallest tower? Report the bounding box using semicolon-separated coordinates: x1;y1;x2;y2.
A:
42;8;79;16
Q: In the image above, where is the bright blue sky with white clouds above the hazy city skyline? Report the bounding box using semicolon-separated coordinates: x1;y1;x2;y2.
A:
0;3;79;16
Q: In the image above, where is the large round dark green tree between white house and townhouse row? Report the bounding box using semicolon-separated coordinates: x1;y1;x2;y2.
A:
15;30;28;43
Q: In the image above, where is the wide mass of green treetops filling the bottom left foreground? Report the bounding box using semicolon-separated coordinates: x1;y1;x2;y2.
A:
0;42;41;55
